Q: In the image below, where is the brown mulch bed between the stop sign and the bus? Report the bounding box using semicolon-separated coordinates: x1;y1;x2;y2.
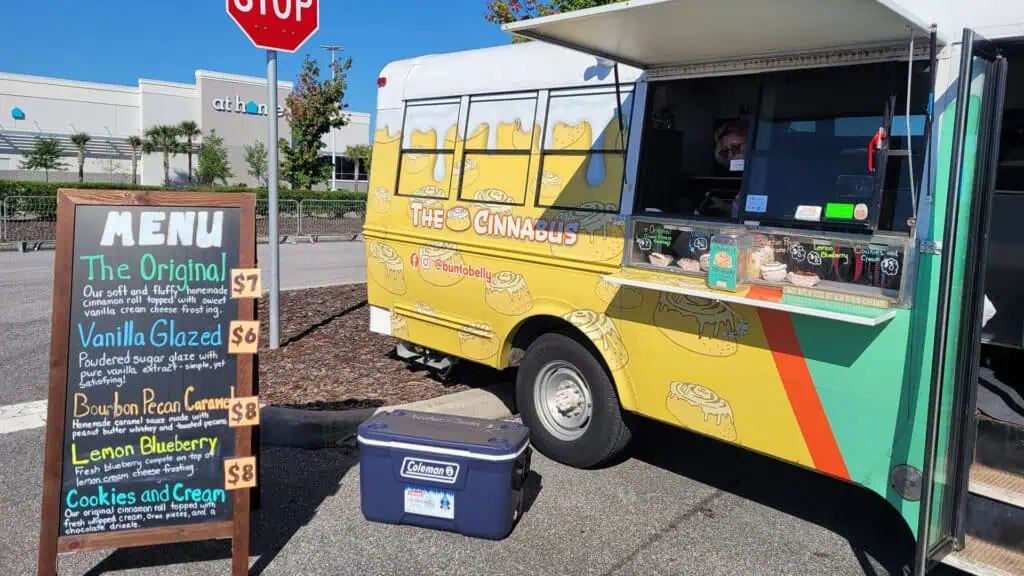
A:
259;284;508;410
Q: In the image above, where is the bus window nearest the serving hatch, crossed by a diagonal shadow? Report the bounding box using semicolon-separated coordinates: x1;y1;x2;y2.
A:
537;85;633;212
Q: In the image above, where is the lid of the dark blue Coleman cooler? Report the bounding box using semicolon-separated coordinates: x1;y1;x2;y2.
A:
359;410;529;457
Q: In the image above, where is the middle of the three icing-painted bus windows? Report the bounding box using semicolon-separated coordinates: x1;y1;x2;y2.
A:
455;93;541;206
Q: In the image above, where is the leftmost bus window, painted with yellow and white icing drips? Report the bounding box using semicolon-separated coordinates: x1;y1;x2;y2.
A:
395;99;459;199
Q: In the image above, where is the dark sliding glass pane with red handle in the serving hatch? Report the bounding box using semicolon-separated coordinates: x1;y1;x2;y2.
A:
739;61;929;232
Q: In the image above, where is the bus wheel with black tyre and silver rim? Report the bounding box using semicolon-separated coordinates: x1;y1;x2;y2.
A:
516;334;630;467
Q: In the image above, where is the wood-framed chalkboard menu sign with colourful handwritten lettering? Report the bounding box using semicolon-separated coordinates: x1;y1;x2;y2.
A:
40;191;255;573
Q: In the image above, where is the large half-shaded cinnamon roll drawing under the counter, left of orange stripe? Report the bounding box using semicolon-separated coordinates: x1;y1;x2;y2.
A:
654;292;745;358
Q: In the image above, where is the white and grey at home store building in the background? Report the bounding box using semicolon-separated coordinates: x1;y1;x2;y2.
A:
0;70;370;190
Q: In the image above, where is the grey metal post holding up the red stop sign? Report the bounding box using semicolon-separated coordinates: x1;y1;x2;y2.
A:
266;50;281;349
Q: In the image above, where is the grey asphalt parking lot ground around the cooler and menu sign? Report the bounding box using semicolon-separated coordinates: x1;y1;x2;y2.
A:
0;244;953;576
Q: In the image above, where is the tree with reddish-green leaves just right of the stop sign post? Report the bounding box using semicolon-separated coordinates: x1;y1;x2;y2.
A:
282;54;352;189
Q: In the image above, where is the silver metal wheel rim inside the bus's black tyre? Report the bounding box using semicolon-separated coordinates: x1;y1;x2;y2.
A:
534;360;594;441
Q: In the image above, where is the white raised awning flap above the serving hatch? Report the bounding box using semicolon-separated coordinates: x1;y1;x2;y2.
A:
504;0;942;69
